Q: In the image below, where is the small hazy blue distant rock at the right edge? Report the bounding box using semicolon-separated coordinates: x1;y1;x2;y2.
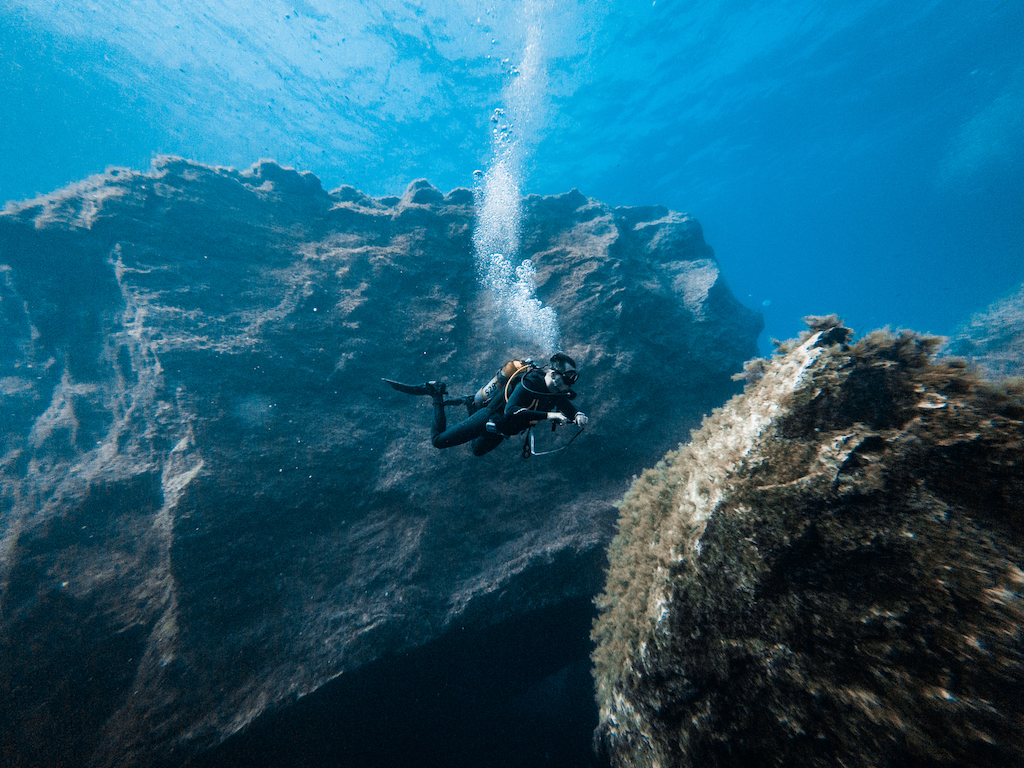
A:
945;286;1024;379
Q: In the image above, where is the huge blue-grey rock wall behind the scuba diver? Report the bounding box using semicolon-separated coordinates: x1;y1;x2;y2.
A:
0;159;761;766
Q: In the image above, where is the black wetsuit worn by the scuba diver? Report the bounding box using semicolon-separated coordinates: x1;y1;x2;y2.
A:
430;369;579;456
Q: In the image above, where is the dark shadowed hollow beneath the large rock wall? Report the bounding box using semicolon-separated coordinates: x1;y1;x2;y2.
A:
188;599;604;768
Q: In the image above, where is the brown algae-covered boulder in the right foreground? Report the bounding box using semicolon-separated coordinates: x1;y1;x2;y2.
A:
594;316;1024;768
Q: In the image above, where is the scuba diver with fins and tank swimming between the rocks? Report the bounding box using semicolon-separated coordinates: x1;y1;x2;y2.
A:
384;352;588;457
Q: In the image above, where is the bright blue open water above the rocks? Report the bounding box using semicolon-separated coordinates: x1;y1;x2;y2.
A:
0;0;1024;349
